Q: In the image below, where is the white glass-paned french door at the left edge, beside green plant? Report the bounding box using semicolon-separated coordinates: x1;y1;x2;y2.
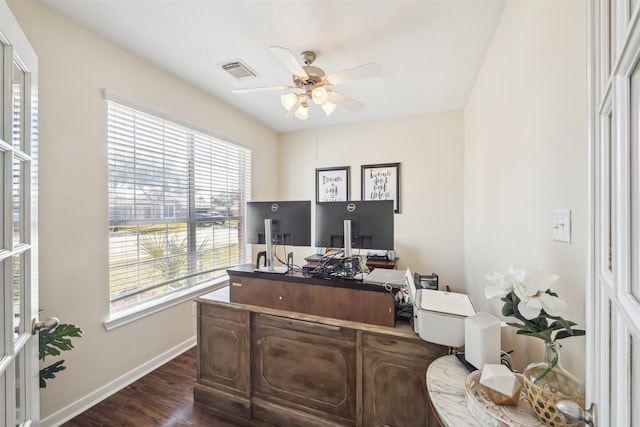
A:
0;0;40;427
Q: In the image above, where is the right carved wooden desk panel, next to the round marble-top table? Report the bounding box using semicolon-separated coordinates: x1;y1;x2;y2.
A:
362;334;446;427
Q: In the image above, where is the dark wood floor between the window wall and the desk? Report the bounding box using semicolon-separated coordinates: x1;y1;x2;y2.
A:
63;348;274;427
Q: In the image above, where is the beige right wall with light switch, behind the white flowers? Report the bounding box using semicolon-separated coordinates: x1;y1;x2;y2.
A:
465;1;587;377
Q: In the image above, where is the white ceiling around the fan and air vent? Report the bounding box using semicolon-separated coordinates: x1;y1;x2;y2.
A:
36;0;504;132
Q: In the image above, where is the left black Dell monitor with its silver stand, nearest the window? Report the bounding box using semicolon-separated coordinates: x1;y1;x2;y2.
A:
247;200;311;273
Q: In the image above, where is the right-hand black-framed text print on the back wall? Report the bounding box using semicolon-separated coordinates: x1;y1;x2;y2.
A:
361;163;400;213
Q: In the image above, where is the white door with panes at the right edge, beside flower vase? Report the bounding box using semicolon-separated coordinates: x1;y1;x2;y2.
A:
587;0;640;427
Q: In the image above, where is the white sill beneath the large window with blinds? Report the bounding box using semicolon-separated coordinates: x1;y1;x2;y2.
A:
104;276;229;331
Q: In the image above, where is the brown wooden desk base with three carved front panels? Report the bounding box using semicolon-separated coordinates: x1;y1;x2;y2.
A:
194;284;447;427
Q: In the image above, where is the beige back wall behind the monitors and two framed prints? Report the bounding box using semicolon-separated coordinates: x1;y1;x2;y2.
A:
280;111;464;291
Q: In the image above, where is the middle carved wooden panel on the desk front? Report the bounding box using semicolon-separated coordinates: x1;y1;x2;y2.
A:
252;315;356;425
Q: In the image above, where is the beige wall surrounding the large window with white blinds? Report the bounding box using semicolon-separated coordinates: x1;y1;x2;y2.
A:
8;0;278;418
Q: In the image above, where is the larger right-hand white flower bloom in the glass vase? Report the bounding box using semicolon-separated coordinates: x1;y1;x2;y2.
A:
513;274;567;320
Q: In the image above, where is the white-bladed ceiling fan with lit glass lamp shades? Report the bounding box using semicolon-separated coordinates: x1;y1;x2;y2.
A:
232;46;380;120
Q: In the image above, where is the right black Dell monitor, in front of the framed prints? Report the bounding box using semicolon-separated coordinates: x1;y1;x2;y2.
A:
315;200;394;257
